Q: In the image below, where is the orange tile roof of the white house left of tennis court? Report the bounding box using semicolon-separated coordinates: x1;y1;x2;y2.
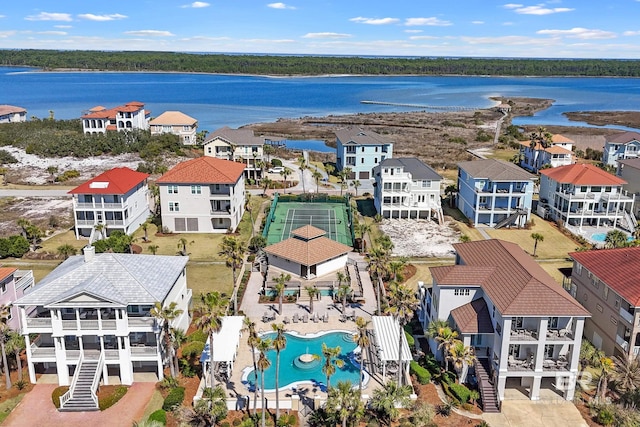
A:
156;156;245;184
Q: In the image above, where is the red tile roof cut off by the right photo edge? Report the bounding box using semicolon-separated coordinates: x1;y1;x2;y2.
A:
569;247;640;307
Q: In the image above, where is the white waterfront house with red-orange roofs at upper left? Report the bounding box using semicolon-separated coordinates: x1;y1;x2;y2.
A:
80;101;151;134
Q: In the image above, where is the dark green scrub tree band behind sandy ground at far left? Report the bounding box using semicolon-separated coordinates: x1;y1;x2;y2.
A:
0;118;183;163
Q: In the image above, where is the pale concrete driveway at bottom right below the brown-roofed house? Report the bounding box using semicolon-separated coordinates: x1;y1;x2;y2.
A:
482;399;588;427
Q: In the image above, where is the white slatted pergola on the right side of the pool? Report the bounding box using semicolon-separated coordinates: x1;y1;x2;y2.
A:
371;316;413;378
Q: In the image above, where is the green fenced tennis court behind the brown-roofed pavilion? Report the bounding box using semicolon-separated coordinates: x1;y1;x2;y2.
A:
264;200;353;246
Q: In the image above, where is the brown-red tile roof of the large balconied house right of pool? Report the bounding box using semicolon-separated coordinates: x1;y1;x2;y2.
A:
448;239;589;316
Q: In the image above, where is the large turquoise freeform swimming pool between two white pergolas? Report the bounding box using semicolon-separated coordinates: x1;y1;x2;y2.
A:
242;331;368;392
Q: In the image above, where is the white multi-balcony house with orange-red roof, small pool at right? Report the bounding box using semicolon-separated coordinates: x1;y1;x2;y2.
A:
540;164;637;234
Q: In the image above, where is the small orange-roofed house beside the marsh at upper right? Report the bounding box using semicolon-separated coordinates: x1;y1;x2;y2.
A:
520;134;575;173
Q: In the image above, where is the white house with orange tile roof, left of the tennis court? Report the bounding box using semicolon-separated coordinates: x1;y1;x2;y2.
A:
156;156;245;233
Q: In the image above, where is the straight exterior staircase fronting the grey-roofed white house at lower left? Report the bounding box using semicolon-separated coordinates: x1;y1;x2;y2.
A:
59;352;104;412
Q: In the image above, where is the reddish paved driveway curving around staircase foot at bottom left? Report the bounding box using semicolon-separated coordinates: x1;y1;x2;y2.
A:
2;382;155;427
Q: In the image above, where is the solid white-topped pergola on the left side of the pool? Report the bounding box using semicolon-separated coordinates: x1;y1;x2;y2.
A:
200;316;244;378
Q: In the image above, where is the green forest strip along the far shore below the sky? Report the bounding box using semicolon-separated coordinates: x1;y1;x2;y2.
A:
0;50;640;77
